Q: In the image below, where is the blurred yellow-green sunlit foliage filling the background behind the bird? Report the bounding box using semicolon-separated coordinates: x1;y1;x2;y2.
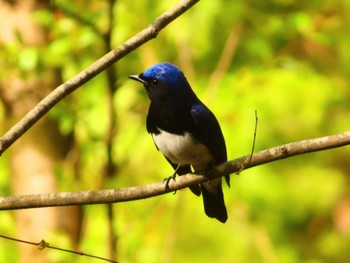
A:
0;0;350;263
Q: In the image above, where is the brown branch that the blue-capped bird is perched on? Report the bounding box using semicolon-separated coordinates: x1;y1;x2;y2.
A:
0;131;350;210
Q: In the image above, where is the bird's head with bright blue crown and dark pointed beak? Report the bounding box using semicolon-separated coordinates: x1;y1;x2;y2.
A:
129;62;194;101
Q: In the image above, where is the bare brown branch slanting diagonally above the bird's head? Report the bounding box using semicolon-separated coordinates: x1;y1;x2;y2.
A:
0;0;199;155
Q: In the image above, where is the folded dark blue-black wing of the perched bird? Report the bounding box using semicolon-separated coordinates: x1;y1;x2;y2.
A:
191;104;230;188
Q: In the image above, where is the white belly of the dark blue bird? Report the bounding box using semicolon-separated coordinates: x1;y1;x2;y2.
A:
152;129;214;170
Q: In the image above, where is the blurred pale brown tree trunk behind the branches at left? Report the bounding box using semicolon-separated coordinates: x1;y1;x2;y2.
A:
0;0;80;263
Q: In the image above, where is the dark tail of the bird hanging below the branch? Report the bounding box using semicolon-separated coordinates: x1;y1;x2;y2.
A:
201;178;227;223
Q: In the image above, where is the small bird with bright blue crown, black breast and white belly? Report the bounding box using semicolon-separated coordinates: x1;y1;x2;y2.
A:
129;62;230;223
